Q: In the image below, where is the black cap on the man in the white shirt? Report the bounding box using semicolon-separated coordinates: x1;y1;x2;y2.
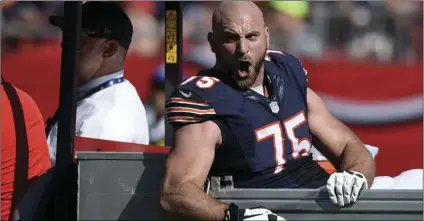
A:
49;1;133;49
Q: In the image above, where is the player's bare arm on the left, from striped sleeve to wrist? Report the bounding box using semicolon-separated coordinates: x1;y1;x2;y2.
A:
161;121;228;220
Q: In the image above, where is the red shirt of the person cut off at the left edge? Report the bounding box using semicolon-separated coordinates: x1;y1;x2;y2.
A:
1;79;51;220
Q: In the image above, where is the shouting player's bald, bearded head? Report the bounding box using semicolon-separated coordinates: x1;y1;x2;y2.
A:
208;1;269;89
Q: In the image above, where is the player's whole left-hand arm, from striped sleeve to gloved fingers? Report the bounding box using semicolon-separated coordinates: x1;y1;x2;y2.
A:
160;77;284;221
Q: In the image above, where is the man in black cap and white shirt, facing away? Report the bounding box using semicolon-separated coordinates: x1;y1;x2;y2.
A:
46;1;149;165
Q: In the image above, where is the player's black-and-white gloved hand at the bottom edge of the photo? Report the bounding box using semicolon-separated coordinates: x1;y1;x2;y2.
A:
225;203;286;221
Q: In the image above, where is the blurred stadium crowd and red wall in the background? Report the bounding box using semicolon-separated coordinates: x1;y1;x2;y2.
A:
1;0;423;176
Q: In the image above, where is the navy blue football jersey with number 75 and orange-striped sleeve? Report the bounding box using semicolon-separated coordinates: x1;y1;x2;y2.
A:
166;51;328;188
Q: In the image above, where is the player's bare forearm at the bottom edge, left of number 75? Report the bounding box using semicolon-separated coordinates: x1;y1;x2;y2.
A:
161;183;228;220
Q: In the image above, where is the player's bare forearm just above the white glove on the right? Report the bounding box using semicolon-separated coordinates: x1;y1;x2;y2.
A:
340;139;375;187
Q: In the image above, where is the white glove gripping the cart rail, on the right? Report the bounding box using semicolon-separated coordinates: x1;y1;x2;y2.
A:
327;171;368;207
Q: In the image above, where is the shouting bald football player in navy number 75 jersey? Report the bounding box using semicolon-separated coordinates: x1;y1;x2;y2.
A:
161;1;375;220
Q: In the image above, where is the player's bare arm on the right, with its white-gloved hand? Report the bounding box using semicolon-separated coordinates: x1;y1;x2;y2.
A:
307;88;375;206
